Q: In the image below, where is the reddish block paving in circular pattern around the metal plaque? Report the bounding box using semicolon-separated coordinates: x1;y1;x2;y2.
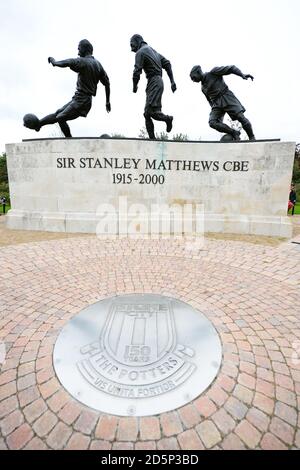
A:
0;224;300;450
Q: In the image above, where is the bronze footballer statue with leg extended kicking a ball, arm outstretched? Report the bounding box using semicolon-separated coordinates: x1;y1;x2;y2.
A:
24;39;111;137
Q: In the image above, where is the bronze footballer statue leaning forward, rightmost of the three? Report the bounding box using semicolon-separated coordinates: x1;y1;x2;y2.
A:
190;65;255;140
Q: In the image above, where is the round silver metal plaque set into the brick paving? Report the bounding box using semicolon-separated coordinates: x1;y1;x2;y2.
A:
54;294;222;416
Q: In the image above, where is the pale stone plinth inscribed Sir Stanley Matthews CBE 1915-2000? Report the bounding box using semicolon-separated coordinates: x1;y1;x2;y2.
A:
6;138;295;237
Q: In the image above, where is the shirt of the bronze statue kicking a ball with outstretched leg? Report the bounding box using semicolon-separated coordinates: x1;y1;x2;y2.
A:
69;56;109;96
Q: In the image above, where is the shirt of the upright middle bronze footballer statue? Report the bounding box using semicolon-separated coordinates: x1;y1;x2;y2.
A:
133;44;171;82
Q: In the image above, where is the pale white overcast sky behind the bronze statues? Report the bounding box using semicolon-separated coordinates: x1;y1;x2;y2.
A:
0;0;300;152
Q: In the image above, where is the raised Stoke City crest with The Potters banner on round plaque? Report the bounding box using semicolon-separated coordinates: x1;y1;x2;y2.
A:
77;301;196;398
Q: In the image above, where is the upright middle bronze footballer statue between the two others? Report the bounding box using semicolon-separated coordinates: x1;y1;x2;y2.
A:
130;34;177;139
